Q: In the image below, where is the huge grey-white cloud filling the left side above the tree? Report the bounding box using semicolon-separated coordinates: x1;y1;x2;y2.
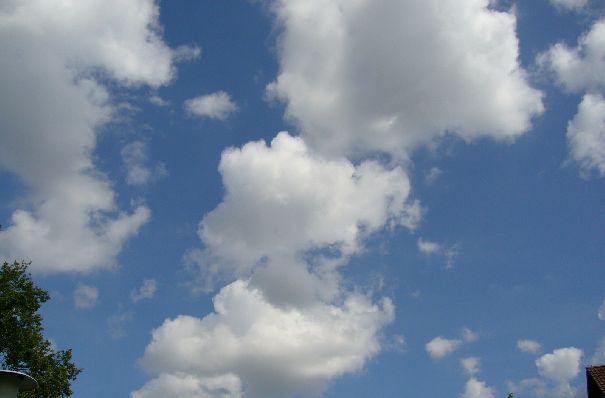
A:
0;0;184;272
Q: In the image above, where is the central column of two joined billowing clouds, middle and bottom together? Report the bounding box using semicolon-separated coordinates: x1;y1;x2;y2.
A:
139;133;408;397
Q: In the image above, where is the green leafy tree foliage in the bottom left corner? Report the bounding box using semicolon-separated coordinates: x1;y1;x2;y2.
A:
0;262;82;398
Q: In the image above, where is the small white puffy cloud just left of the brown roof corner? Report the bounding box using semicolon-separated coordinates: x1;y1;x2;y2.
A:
536;347;583;384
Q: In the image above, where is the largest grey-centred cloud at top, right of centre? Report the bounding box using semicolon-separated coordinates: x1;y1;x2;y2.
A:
267;0;543;158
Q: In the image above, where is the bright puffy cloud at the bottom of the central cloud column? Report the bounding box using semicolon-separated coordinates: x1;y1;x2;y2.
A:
140;280;394;397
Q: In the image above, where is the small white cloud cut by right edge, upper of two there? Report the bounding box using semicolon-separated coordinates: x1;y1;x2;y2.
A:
538;19;605;93
